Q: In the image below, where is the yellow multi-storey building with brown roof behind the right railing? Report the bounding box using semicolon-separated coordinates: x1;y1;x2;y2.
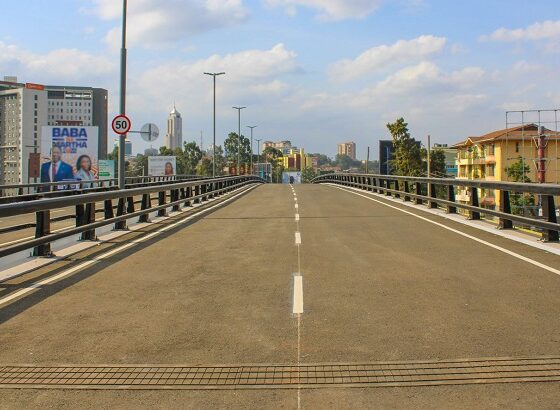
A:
453;124;560;209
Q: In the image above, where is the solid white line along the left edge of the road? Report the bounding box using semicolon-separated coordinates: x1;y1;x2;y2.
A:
0;185;256;306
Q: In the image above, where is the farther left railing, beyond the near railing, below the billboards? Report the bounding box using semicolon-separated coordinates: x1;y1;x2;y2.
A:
0;175;205;199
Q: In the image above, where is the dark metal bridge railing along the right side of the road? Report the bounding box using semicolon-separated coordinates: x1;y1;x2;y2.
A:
312;173;560;242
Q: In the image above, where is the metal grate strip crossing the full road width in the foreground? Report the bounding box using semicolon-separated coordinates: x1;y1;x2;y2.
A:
0;357;560;389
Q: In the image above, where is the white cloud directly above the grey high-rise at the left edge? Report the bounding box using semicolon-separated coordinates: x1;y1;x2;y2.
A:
0;41;117;84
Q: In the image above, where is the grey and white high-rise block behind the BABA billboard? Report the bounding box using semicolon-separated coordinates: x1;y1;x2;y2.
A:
0;77;107;184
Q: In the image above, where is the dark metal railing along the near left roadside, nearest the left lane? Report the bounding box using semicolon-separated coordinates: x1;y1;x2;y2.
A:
0;175;264;257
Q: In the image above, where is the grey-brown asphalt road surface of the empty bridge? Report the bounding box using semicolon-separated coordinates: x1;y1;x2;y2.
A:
0;185;560;409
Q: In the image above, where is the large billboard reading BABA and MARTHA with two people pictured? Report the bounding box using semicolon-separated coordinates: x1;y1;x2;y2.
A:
41;126;99;188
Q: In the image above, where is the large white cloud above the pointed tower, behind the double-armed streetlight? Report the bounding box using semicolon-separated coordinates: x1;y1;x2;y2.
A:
129;44;301;128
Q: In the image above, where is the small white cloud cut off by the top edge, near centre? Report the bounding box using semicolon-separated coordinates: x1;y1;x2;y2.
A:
266;0;381;20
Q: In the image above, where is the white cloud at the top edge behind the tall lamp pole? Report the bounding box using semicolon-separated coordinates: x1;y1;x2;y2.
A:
92;0;248;49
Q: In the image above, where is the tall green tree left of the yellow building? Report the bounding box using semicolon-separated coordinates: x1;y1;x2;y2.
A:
387;117;424;176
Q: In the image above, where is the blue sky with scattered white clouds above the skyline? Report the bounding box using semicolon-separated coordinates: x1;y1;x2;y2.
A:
0;0;560;156
